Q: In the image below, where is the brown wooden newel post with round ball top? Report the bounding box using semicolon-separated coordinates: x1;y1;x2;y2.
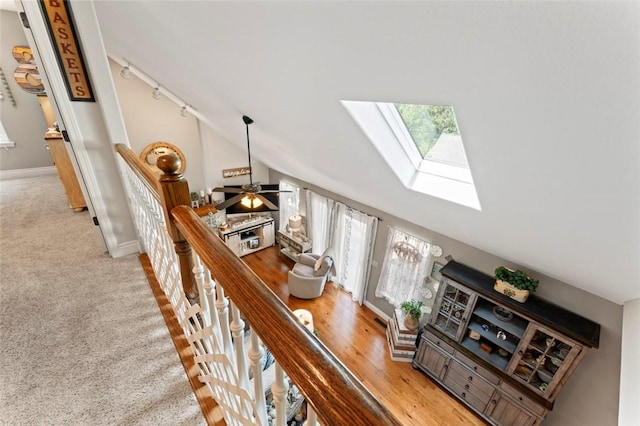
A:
156;154;198;302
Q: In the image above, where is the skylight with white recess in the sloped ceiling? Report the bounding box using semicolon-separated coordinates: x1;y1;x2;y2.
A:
342;101;480;210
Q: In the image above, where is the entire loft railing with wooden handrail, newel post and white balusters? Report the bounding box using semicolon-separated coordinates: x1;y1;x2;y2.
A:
116;145;399;426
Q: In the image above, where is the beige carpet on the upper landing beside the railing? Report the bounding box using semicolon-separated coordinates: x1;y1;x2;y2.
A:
0;175;205;425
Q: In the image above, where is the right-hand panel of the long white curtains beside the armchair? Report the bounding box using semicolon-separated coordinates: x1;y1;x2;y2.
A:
331;202;378;304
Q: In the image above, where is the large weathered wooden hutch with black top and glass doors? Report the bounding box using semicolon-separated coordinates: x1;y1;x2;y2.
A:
413;261;600;426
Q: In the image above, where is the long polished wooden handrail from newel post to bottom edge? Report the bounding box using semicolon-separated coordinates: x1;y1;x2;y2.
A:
171;206;401;425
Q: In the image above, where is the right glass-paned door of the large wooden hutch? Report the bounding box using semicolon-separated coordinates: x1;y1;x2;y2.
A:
510;326;580;398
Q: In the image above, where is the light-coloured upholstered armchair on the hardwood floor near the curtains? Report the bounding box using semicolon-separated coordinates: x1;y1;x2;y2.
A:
289;249;335;299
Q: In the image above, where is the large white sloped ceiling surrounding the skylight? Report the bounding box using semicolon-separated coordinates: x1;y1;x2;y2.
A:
95;1;640;303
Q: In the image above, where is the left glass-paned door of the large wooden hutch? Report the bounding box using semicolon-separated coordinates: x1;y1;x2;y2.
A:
431;278;477;341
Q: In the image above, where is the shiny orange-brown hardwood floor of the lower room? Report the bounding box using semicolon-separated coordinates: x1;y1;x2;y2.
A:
242;247;486;425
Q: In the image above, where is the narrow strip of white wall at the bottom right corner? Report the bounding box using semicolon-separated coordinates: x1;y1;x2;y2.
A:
618;299;640;426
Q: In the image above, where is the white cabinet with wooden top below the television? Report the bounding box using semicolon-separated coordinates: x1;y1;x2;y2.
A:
218;217;275;257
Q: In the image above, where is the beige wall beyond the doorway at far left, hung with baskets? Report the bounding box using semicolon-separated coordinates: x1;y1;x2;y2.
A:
0;10;53;171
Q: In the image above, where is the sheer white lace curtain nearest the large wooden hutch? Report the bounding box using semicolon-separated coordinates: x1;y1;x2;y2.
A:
376;228;430;307
